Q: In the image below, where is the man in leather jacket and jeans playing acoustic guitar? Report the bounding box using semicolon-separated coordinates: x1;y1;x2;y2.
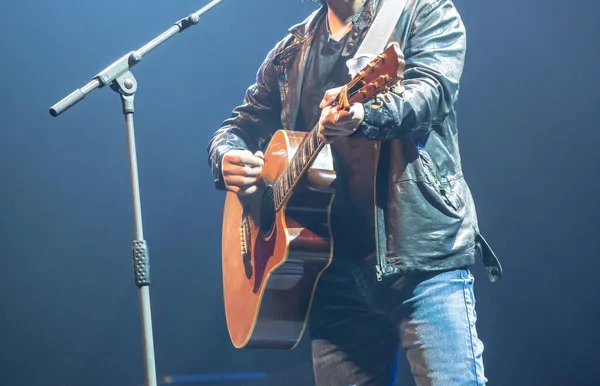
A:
208;0;501;386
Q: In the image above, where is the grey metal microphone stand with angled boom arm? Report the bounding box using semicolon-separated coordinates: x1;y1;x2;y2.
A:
50;0;223;386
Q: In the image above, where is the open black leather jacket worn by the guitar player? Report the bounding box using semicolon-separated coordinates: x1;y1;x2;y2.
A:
208;0;502;281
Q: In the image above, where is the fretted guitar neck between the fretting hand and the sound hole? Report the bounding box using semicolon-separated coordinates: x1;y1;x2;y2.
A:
273;123;325;210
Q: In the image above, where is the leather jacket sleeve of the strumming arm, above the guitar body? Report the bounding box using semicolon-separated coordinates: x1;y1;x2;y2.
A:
207;47;281;190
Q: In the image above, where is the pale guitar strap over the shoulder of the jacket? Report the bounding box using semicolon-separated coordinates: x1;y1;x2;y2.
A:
346;0;406;76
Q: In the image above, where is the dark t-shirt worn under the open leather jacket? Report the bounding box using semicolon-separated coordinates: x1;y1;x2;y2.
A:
297;21;376;259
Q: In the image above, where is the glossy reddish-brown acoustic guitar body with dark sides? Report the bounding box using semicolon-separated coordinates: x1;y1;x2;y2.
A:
222;130;335;349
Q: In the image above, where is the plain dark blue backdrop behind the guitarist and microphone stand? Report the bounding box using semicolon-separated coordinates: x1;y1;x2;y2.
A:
0;0;600;386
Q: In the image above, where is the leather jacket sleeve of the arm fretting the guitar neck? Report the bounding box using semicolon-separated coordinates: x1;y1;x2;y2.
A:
356;0;466;140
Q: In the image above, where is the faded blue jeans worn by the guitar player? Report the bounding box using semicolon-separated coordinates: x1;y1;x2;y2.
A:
309;259;487;386
